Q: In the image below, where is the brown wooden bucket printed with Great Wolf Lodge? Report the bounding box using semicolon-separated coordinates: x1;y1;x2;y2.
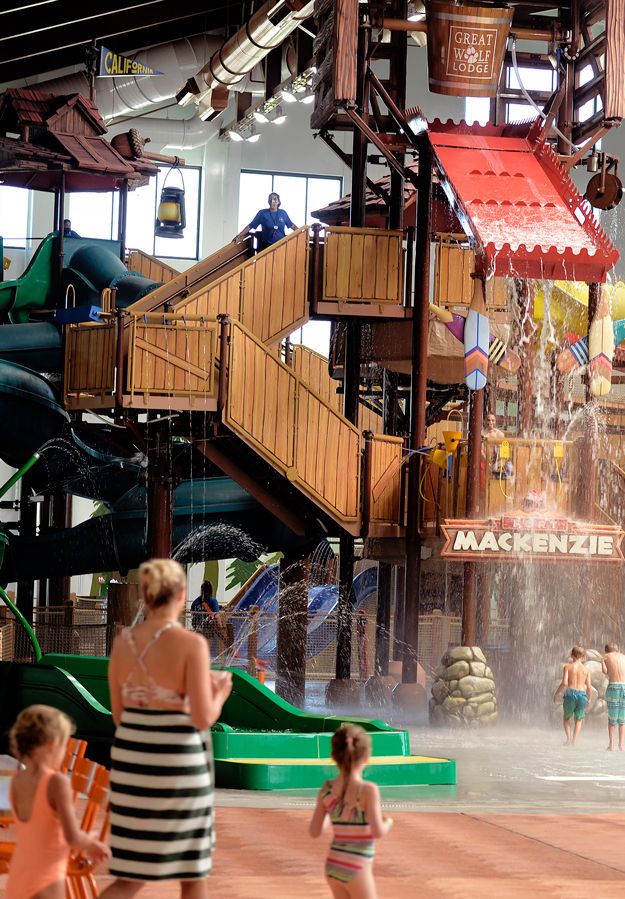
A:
427;0;514;97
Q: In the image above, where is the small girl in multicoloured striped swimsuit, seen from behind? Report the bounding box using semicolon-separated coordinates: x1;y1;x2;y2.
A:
310;724;393;899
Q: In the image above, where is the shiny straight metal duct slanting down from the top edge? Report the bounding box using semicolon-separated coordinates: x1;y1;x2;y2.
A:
176;0;315;120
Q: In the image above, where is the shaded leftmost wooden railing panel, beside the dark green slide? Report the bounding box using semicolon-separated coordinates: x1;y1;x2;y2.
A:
63;321;117;409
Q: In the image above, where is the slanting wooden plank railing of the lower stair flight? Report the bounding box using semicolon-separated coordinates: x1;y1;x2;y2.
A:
224;322;360;524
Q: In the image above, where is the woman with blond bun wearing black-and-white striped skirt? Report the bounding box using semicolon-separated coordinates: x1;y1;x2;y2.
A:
102;559;232;899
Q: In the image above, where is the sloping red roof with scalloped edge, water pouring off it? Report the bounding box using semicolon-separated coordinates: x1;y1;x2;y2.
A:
428;119;619;281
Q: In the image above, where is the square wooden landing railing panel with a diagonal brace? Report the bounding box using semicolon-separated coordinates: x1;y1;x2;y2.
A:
123;313;219;410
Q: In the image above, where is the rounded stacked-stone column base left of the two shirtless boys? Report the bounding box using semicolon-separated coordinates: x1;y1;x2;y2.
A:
430;646;497;727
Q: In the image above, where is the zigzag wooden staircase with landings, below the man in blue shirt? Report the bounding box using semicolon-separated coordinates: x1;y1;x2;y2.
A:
64;228;404;536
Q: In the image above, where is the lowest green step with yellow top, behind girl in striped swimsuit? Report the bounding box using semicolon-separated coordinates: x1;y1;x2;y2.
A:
215;755;456;790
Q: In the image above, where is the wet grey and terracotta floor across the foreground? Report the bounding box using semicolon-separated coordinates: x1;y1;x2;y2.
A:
0;721;625;899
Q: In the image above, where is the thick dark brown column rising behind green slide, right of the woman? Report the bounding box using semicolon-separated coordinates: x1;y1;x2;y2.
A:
276;556;310;708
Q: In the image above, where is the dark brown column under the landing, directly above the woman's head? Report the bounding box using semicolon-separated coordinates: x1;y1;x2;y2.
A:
147;420;174;559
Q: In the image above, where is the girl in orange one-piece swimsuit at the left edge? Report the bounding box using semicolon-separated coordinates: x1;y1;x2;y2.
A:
6;705;111;899
